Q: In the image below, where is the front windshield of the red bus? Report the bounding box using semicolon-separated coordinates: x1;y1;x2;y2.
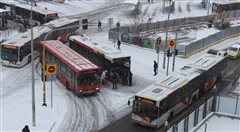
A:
77;73;100;86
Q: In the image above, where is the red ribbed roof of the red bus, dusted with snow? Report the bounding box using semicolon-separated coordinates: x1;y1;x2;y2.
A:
41;40;100;74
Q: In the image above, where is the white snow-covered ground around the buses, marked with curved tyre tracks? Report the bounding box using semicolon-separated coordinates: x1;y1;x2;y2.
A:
0;0;240;132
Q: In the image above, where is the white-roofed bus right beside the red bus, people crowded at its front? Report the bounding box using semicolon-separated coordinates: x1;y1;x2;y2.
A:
69;35;131;83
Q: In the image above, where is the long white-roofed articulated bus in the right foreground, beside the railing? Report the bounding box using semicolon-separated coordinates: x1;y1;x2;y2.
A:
128;54;227;128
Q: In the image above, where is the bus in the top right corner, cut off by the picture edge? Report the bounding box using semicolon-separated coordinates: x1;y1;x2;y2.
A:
212;0;240;14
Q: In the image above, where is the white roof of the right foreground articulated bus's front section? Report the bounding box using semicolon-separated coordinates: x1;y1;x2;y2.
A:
135;67;203;101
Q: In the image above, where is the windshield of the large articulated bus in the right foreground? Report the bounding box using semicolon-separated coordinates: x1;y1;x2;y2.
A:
133;100;158;120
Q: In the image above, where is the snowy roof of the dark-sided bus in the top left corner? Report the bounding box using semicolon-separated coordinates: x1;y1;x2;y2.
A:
1;0;57;15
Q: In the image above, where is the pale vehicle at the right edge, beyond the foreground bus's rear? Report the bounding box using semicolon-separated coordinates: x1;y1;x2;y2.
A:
227;43;240;59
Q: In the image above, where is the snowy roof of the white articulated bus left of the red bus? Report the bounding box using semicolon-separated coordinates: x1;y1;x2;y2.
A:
2;26;51;47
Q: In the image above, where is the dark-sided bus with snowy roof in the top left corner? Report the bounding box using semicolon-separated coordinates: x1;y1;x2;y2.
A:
0;1;58;26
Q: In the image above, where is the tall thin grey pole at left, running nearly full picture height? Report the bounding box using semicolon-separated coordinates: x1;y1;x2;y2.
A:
30;0;36;126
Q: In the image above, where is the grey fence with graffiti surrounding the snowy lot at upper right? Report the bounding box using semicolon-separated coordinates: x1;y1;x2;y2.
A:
108;10;240;57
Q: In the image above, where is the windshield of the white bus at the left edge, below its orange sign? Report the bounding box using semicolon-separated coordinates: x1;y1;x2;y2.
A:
1;45;18;61
